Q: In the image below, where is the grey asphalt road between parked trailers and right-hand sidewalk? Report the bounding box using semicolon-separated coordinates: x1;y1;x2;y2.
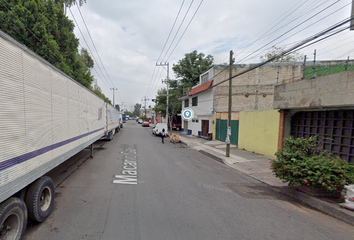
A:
24;121;354;240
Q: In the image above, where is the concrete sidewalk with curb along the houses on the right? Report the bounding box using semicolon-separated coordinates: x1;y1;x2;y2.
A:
180;134;354;225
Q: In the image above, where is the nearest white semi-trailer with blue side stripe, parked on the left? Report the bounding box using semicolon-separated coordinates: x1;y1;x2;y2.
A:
0;31;119;240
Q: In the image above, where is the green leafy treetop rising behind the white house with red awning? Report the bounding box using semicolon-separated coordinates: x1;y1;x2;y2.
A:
172;50;214;87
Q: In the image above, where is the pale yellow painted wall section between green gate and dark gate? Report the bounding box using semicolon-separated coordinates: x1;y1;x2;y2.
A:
238;110;280;157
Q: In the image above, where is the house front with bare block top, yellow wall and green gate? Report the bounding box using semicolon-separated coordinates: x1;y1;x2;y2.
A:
213;63;303;157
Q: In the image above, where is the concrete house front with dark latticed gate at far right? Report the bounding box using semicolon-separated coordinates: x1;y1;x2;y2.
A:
274;61;354;164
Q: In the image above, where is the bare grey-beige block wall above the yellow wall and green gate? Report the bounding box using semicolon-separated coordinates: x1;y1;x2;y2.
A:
213;63;302;112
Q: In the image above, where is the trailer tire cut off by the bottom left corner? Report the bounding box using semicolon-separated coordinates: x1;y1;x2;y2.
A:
0;197;27;240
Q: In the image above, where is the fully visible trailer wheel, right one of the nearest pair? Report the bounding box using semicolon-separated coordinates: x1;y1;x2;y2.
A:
26;176;54;223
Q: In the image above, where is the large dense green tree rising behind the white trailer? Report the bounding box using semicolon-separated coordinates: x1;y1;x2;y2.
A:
0;0;109;101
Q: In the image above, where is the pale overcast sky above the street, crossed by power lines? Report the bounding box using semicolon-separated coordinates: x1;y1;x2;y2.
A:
67;0;354;110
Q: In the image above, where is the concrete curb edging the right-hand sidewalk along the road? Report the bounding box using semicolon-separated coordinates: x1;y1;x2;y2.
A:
181;140;354;226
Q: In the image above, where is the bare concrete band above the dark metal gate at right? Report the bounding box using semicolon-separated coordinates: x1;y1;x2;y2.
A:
274;71;354;109
